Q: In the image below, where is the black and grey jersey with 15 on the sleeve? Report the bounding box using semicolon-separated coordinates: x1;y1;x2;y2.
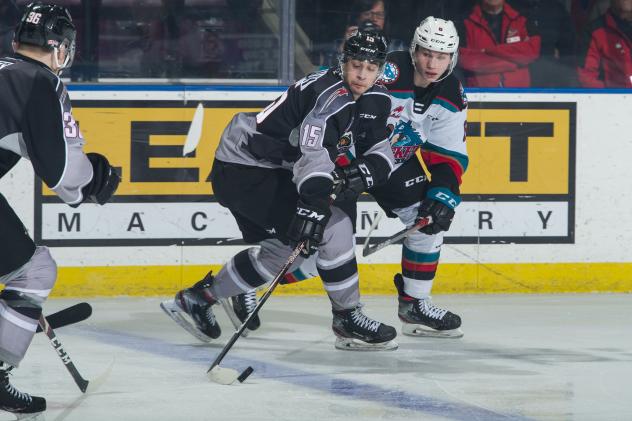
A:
215;68;394;198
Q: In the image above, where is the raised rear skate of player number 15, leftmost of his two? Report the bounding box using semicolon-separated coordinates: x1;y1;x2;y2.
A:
160;272;222;342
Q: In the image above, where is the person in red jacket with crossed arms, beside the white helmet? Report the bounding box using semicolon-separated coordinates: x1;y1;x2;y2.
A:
459;0;540;87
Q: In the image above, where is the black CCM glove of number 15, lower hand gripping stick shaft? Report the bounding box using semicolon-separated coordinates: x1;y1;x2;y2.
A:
287;200;331;257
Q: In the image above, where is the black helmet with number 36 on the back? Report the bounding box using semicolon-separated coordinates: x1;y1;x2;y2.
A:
13;2;77;69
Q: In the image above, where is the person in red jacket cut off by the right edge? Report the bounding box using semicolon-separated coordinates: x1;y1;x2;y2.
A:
577;0;632;88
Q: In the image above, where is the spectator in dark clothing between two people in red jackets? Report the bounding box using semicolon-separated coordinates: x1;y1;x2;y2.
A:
512;0;577;88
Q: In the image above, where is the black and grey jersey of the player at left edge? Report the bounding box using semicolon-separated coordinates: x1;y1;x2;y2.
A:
0;54;93;204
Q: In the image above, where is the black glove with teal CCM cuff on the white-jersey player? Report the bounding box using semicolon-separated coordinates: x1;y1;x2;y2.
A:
415;187;461;235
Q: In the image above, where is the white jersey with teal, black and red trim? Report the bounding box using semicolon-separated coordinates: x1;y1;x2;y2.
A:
382;51;468;189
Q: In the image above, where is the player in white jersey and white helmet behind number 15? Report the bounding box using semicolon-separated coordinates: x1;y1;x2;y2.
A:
232;16;468;338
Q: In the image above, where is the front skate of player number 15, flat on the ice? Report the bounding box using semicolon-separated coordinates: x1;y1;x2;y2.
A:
331;304;398;351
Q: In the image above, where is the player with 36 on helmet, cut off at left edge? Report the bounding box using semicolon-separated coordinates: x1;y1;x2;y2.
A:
0;3;119;414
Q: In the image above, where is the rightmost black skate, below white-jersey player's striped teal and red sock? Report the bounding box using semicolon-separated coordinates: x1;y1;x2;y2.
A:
394;273;463;338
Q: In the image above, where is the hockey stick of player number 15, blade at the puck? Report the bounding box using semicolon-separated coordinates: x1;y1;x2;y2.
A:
206;240;306;384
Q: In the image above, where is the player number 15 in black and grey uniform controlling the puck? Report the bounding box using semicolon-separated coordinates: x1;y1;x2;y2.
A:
161;32;397;350
